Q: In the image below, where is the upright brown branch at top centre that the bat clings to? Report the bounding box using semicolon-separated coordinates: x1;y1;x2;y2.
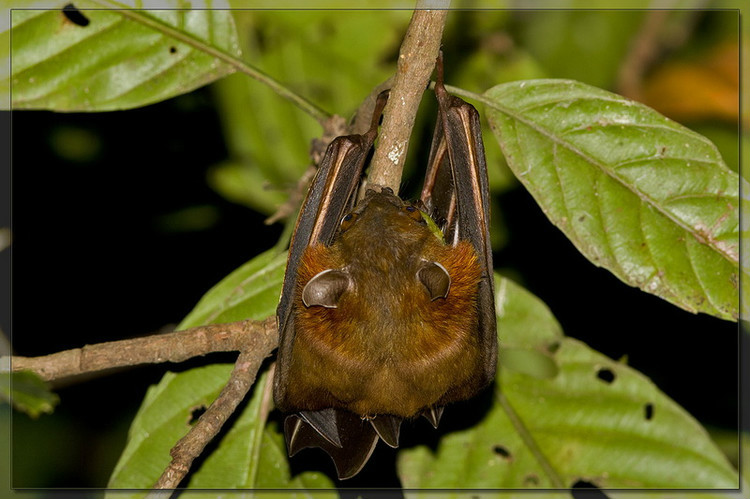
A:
368;1;450;192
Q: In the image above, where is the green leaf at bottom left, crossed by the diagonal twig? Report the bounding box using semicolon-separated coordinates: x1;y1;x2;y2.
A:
105;365;332;498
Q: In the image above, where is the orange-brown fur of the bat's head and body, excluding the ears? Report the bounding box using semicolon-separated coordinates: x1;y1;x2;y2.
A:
287;193;481;417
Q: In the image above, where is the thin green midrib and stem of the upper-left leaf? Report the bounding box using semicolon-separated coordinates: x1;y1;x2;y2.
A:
90;0;330;124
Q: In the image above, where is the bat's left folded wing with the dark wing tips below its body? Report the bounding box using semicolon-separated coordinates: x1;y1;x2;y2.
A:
274;92;394;479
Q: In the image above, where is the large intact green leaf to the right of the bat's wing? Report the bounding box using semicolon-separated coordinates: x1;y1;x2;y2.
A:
482;80;739;320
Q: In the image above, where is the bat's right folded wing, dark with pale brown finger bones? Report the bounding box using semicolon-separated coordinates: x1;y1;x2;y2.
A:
421;57;497;390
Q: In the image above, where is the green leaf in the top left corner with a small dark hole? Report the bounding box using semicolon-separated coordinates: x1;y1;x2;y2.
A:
10;0;240;111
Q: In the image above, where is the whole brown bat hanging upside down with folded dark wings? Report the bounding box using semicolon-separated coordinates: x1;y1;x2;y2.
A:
274;60;497;479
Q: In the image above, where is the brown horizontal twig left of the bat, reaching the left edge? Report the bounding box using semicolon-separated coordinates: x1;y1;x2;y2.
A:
10;317;278;381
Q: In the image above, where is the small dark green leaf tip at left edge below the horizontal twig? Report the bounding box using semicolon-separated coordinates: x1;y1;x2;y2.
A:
0;371;60;418
